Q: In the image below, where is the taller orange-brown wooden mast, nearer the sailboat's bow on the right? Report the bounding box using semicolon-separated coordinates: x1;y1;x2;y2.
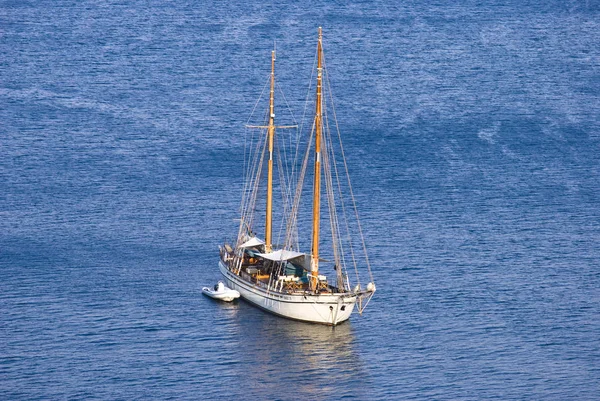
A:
310;27;323;291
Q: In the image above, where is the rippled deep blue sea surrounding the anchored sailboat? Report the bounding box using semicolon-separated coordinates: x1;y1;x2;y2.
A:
0;0;600;400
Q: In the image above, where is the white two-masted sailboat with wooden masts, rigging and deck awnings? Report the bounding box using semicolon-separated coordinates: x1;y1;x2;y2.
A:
219;28;376;326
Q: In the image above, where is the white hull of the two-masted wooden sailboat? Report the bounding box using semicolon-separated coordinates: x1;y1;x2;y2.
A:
219;261;356;326
